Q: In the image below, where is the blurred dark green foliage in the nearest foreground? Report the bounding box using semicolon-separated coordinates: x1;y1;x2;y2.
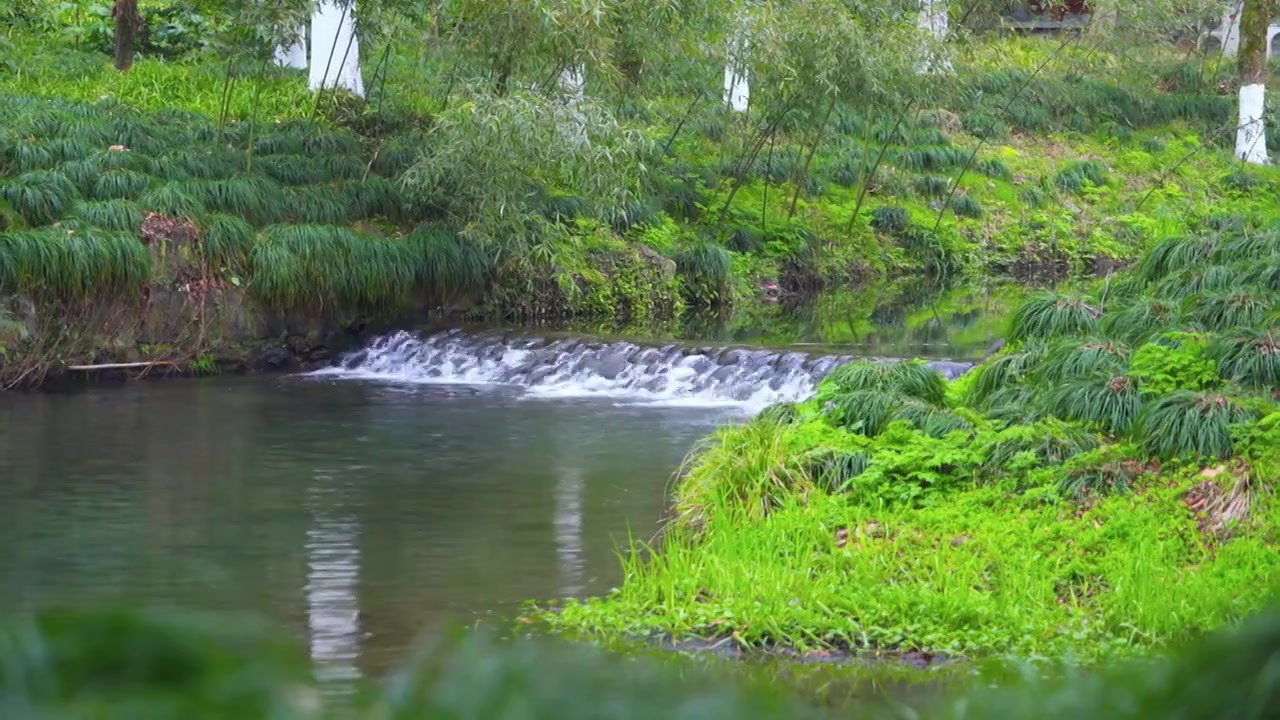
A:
0;602;1280;720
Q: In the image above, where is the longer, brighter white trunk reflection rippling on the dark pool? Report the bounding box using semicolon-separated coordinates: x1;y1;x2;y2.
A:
306;475;360;682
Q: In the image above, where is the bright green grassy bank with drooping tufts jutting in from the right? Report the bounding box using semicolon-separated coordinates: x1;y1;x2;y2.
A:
543;218;1280;659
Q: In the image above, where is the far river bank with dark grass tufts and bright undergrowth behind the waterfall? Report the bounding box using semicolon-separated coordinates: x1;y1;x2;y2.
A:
0;30;1280;384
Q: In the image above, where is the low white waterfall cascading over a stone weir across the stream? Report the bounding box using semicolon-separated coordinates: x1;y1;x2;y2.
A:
314;331;973;409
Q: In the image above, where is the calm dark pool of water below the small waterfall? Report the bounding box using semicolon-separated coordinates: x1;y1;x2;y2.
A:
0;377;733;678
